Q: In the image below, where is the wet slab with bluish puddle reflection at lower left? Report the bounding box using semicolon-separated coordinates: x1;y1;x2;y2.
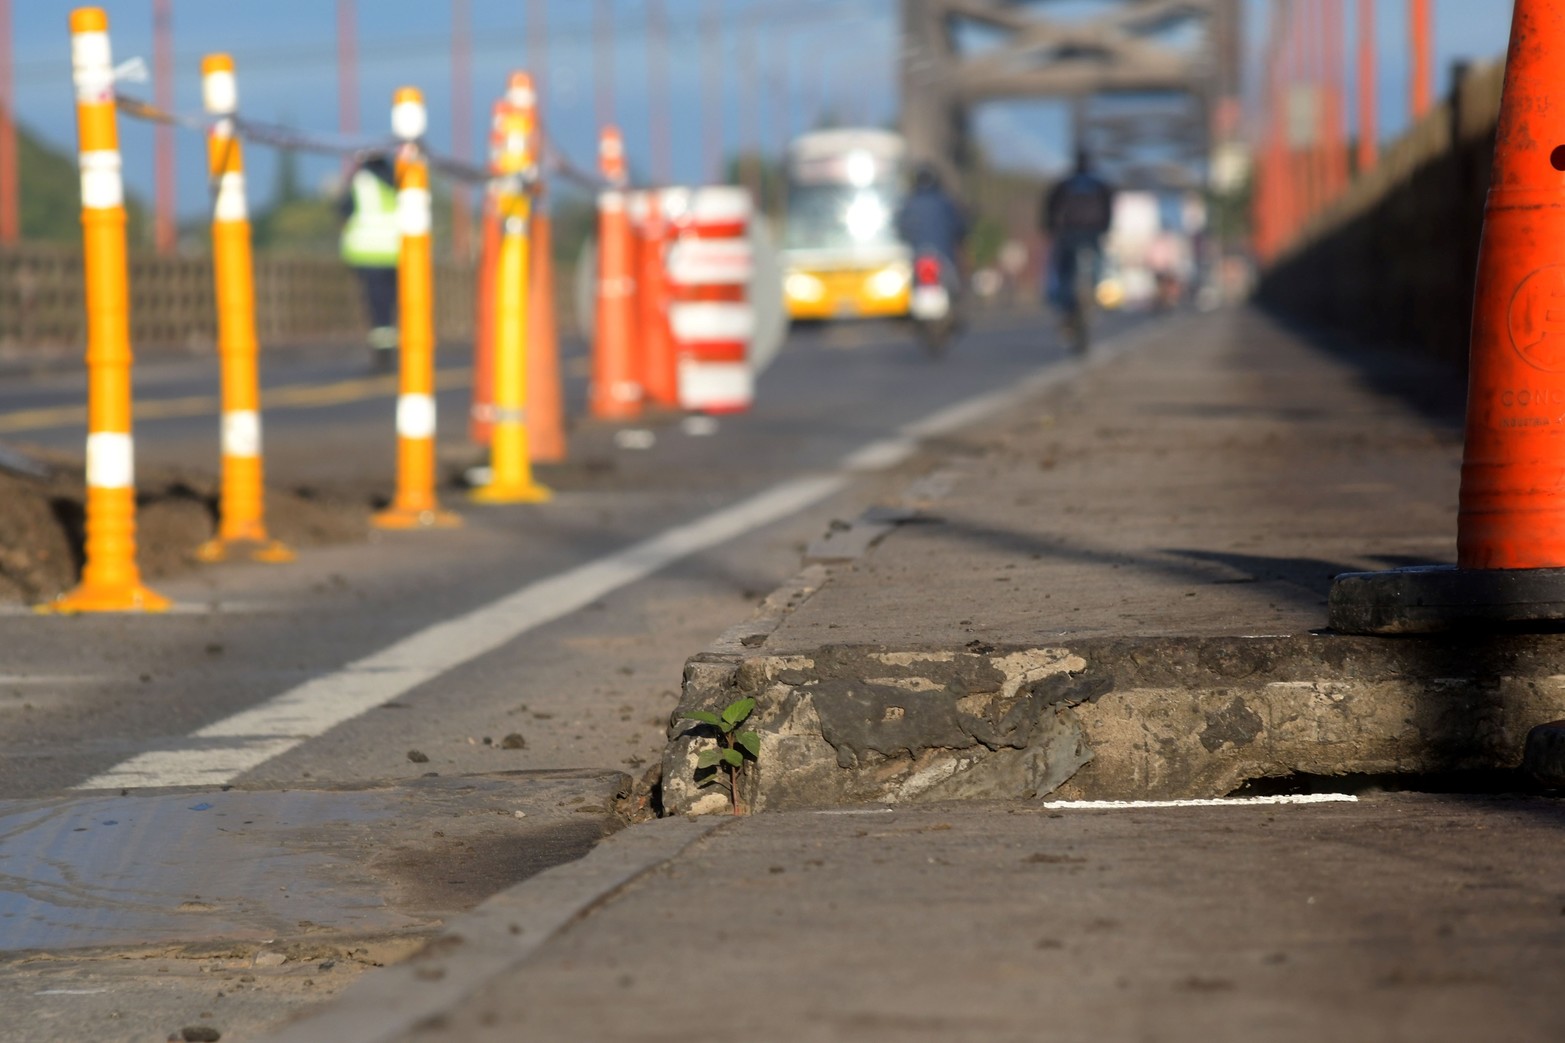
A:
0;772;628;957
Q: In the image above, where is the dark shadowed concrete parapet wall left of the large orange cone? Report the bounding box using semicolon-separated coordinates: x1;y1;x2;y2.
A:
1257;64;1504;366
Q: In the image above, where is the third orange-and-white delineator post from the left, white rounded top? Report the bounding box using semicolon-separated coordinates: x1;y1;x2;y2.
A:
371;88;462;529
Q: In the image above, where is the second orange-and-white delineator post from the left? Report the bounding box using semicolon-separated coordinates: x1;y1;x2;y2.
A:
196;55;294;562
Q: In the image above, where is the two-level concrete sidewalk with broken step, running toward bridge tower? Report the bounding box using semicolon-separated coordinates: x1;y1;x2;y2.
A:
266;312;1565;1041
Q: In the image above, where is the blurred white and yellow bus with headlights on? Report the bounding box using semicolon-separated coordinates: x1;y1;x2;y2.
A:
783;130;912;319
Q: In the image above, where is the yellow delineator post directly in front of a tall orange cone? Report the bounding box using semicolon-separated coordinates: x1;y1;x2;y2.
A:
470;74;552;503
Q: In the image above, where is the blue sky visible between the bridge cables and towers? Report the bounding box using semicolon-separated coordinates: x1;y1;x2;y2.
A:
0;0;1510;215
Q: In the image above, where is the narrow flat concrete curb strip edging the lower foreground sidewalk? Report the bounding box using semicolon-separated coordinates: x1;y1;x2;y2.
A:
266;817;731;1043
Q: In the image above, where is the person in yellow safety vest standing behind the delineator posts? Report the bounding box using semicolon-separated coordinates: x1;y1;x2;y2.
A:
338;155;402;371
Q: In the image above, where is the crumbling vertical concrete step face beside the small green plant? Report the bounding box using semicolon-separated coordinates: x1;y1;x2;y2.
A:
662;634;1565;814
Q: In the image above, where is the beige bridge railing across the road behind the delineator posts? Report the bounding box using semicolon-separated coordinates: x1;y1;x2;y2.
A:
0;243;476;360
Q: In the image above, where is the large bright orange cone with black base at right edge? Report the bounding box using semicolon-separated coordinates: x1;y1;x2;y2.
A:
1330;0;1565;633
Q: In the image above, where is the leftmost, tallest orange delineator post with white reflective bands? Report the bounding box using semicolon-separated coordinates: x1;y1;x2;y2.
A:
42;8;169;612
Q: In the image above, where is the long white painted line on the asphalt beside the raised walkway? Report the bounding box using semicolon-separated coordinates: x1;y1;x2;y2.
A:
75;325;1145;789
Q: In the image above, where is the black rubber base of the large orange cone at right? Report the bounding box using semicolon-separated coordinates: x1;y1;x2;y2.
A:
1327;565;1565;634
